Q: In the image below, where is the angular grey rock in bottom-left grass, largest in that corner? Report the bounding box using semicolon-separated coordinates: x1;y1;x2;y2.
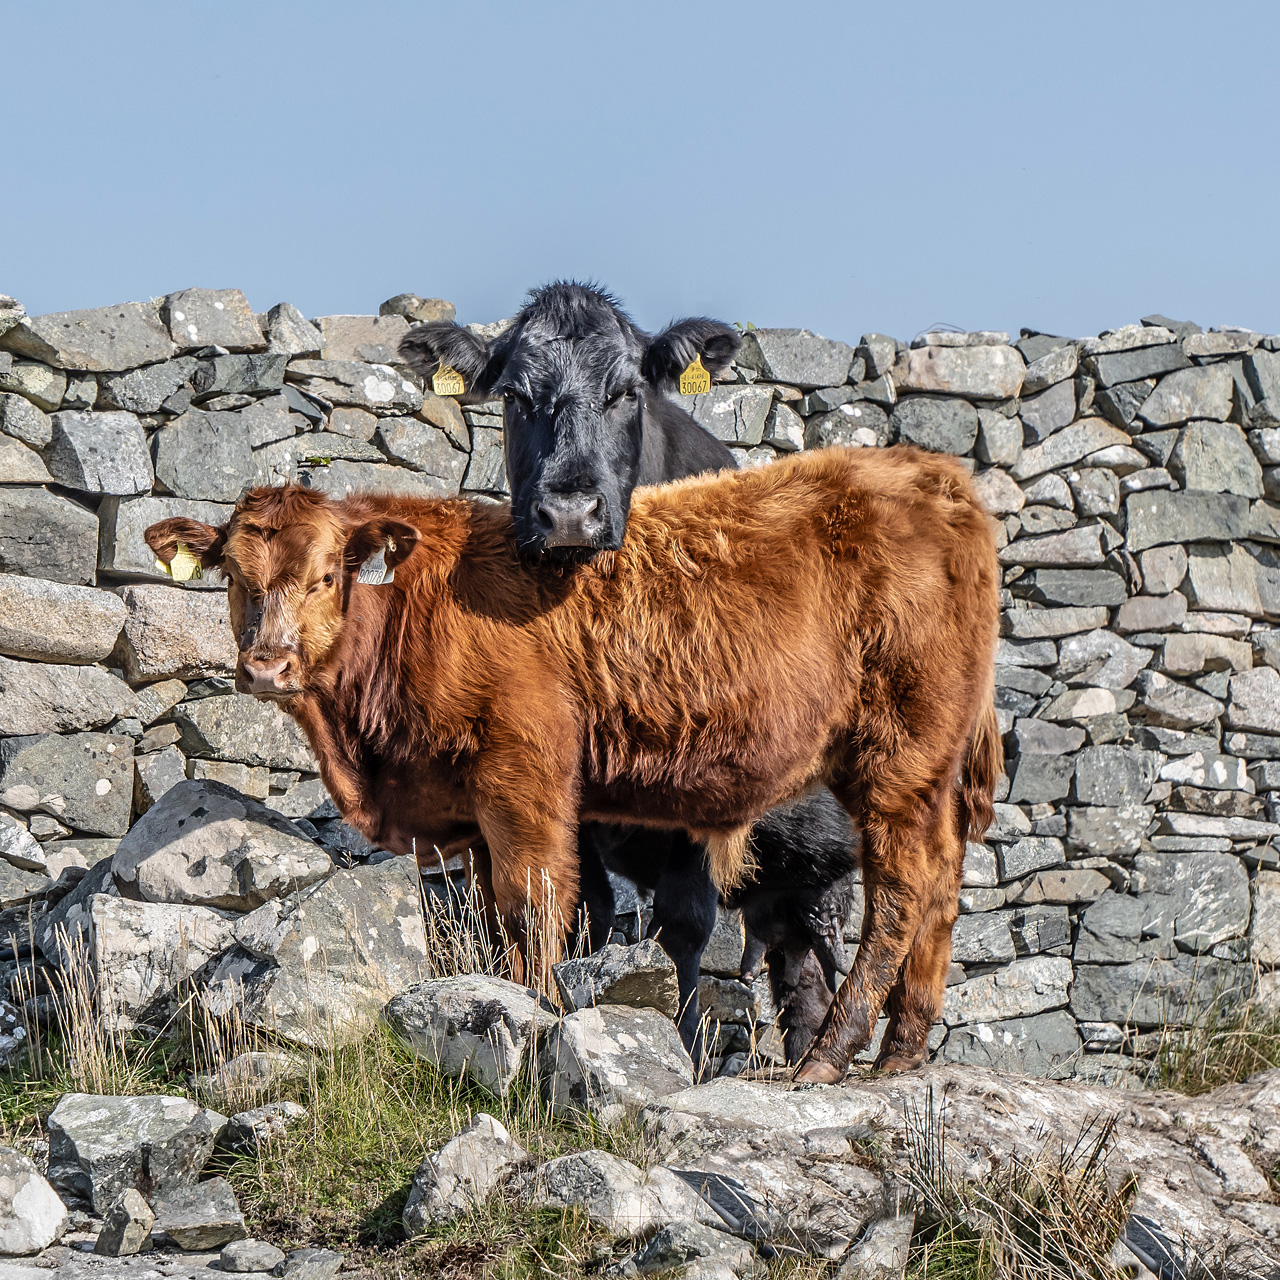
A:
49;1093;227;1213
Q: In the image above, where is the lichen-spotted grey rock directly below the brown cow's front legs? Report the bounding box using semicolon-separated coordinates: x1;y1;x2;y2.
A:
385;974;552;1096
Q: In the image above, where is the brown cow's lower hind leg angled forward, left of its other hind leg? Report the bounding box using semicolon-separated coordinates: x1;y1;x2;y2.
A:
796;815;927;1084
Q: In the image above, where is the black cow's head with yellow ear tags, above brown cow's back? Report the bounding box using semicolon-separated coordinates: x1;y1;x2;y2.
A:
401;283;739;561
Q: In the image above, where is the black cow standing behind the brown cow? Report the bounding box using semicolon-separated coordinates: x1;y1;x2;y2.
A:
401;283;855;1061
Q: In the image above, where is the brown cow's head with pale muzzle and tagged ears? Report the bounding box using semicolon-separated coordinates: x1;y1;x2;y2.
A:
145;485;419;700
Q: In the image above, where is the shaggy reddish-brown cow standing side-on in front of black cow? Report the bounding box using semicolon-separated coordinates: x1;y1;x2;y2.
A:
146;448;1001;1080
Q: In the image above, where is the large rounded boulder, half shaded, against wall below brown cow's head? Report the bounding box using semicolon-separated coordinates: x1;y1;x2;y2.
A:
111;781;333;911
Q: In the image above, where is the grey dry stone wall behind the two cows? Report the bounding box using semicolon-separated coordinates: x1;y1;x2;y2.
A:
0;289;1280;1083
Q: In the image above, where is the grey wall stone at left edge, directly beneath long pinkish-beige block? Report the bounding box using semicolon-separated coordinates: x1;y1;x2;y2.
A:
0;655;134;735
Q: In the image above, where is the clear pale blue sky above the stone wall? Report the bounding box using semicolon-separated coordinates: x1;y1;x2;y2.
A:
0;0;1280;339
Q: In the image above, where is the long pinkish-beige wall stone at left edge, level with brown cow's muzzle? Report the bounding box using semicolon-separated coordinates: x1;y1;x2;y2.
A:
0;573;125;665
